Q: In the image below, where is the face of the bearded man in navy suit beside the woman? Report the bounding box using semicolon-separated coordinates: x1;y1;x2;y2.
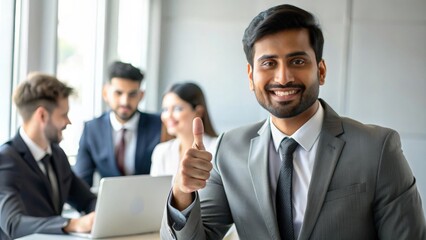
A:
103;78;143;123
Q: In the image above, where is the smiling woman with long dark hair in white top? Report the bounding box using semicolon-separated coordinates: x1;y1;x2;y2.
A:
150;82;217;176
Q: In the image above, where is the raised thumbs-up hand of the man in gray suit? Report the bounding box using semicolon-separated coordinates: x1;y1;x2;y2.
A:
172;117;213;210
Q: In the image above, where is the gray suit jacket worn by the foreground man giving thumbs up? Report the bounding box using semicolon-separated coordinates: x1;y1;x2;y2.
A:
161;100;426;240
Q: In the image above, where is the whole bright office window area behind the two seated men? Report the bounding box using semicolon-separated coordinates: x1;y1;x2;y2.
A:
0;0;152;159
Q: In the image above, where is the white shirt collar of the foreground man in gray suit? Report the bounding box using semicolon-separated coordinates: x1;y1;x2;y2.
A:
269;103;324;152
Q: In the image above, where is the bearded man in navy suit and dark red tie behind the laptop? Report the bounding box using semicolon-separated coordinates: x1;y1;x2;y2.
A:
74;61;161;186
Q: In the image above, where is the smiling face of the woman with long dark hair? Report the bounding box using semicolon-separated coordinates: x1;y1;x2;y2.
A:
161;92;199;136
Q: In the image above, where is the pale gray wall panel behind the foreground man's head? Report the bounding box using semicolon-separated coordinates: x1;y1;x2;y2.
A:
156;0;348;132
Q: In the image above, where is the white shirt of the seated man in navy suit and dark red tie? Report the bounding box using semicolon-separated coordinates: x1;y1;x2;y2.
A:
109;111;140;175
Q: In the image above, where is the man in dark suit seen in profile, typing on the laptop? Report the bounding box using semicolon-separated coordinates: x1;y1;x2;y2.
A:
0;73;96;240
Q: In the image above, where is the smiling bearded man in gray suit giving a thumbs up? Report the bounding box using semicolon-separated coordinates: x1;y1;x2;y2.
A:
161;5;426;240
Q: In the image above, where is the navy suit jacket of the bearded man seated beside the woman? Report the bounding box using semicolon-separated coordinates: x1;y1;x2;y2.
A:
73;112;161;186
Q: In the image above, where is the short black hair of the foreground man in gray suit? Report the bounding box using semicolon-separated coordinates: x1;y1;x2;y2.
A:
243;4;324;66
